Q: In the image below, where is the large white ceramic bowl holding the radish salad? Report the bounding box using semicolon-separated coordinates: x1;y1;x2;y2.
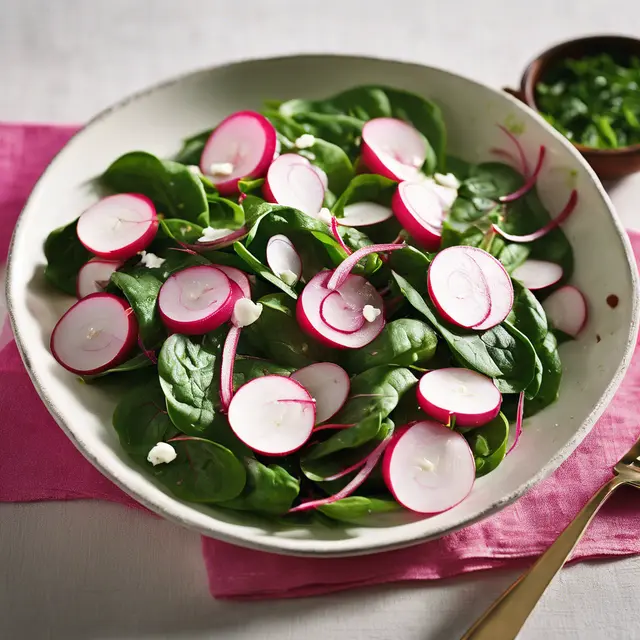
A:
7;56;638;556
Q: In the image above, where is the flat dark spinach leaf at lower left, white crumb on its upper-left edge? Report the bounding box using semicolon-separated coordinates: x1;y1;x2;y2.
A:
149;436;246;502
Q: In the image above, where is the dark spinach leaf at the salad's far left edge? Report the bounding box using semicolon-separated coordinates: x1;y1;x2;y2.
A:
44;220;92;296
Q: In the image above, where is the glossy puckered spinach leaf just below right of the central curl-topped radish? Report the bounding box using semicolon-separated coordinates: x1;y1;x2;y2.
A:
343;318;438;373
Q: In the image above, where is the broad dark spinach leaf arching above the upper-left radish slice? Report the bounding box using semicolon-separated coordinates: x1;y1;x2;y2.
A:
100;151;209;222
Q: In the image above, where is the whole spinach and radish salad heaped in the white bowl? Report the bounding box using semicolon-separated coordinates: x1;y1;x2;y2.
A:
45;86;587;522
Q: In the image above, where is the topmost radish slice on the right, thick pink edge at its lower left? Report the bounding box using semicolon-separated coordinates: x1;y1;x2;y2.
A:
361;118;427;181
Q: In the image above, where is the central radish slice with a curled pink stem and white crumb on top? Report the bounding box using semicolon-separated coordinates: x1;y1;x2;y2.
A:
296;272;384;349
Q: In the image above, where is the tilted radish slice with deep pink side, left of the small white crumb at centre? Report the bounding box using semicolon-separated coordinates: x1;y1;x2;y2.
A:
158;265;234;335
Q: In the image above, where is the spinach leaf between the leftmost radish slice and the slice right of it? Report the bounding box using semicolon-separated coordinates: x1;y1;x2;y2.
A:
111;269;165;349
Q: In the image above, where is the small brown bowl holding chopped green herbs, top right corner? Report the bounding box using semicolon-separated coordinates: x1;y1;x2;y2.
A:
505;36;640;180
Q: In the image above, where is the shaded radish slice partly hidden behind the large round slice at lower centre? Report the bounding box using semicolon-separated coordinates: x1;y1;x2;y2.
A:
291;362;351;424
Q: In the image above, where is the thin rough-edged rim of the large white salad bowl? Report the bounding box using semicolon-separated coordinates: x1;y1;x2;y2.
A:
5;53;640;557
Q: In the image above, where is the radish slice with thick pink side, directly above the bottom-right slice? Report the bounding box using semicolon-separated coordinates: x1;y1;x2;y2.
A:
417;367;502;427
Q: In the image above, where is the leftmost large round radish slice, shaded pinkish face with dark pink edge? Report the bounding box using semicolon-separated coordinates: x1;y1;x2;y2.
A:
50;293;138;375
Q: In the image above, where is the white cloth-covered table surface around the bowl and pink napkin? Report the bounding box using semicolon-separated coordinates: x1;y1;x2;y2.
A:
0;0;640;640
